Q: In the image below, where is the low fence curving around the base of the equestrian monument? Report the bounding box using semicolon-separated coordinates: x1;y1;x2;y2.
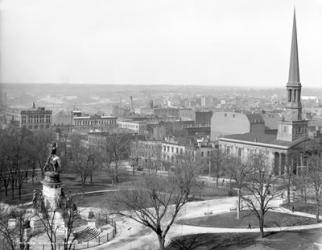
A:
29;221;117;250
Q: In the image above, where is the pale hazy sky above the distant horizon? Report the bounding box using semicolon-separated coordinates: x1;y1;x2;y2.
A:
1;0;322;87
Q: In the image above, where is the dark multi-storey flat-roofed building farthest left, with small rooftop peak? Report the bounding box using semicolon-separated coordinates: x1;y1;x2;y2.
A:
19;103;52;130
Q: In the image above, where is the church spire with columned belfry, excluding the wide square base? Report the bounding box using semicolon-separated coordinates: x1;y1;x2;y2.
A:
285;9;302;121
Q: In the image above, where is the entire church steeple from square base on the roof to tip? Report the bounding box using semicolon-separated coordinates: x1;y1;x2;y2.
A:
277;10;307;142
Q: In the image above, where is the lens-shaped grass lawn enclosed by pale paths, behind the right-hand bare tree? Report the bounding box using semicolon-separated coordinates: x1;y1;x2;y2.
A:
177;210;315;228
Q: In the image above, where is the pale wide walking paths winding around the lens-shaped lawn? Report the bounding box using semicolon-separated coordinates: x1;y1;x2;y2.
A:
90;197;322;250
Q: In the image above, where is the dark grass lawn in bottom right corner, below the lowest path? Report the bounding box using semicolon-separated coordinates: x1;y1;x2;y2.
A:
166;229;322;250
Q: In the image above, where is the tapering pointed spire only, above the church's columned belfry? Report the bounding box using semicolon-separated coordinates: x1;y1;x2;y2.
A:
287;8;300;85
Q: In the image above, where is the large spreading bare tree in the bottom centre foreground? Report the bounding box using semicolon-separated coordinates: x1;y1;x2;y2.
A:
115;155;196;249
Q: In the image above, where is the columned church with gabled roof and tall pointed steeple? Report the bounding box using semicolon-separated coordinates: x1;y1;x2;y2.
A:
219;11;308;175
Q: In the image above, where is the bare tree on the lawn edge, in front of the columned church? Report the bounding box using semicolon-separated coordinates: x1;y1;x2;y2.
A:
241;154;278;237
